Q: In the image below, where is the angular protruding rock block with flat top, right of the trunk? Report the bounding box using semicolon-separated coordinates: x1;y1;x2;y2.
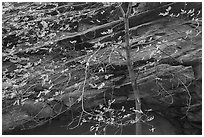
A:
138;64;194;96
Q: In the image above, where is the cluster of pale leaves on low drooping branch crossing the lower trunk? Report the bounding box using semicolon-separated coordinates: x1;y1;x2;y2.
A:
71;99;155;135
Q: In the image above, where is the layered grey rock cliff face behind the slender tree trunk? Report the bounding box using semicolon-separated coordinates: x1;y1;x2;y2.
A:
3;3;202;134
